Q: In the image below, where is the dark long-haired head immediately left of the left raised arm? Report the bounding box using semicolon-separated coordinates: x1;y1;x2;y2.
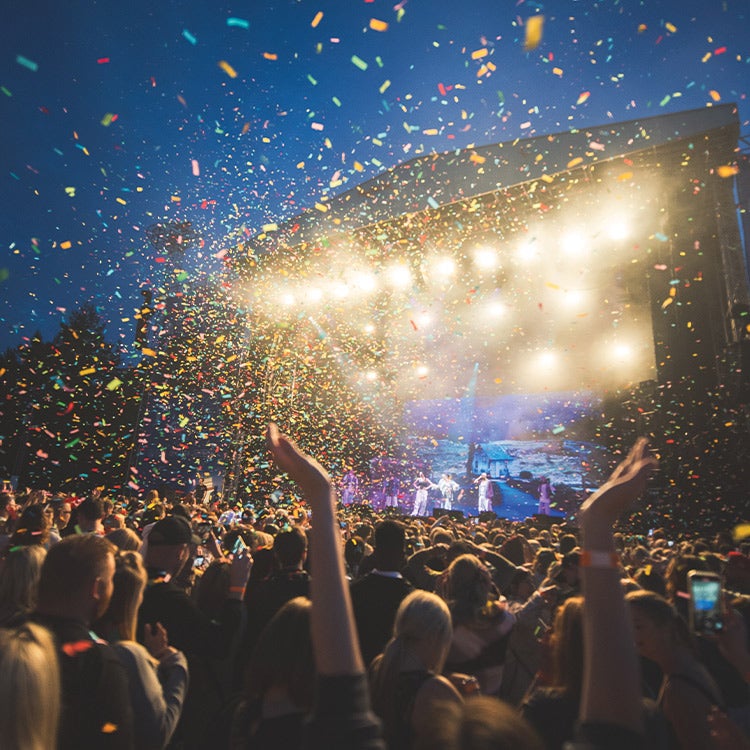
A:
239;596;315;713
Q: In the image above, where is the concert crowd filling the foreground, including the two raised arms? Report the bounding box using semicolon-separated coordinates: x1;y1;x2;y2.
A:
0;434;750;750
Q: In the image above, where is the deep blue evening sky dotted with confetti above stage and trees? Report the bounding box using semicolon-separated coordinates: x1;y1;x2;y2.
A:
0;0;750;353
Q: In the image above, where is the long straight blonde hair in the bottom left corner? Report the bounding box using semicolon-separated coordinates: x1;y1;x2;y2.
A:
0;623;60;750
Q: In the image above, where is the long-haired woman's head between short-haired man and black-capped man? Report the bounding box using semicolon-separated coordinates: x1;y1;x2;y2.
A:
94;552;146;641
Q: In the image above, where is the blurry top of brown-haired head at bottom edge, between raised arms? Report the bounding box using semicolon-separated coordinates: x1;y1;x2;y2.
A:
414;695;544;750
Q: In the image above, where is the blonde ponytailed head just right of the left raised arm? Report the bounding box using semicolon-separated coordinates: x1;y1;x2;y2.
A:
371;590;453;738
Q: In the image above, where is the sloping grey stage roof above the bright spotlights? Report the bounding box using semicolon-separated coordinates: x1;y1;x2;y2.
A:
246;104;739;252
